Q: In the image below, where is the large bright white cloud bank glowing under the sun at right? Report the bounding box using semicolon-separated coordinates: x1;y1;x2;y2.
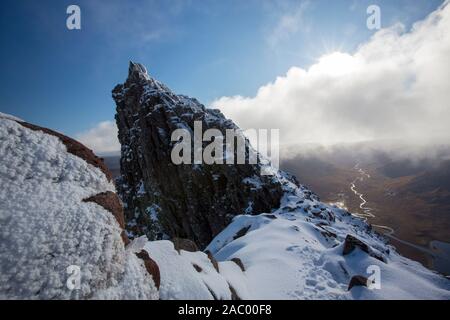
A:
211;1;450;148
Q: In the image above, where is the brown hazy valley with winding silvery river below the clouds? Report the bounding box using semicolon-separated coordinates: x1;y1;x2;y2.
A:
282;145;450;276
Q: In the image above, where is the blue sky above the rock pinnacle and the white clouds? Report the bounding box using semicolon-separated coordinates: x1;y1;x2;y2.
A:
0;0;443;135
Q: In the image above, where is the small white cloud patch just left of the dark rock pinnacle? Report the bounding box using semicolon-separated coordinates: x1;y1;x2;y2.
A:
75;121;120;155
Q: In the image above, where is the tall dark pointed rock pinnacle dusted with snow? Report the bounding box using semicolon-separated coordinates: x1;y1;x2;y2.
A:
113;63;283;248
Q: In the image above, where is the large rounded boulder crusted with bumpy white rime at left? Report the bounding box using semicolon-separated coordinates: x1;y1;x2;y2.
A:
0;114;158;299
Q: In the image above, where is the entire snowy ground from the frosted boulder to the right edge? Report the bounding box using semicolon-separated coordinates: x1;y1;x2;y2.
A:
144;168;450;300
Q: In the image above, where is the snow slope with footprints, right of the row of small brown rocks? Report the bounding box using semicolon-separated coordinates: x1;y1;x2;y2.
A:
207;175;450;299
